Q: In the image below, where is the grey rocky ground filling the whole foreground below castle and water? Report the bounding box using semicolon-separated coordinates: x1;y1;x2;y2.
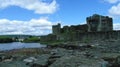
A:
0;40;120;67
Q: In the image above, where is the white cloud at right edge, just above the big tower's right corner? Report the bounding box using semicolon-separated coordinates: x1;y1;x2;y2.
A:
109;3;120;16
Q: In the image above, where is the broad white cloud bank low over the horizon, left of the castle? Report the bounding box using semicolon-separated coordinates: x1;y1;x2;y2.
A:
0;18;56;35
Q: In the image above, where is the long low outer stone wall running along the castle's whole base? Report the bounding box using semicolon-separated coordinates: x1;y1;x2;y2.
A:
41;30;120;42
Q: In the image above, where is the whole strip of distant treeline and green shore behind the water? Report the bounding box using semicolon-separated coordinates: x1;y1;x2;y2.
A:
0;35;40;43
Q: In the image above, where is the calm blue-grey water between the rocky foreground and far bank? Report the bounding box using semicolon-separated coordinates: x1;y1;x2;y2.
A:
0;42;46;50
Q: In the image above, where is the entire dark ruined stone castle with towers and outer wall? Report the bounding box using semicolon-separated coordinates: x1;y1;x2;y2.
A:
41;14;120;41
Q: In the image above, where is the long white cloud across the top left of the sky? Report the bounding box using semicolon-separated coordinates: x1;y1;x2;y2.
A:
0;0;58;14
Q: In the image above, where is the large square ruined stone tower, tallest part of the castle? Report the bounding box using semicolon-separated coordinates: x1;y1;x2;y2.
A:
86;14;113;32
